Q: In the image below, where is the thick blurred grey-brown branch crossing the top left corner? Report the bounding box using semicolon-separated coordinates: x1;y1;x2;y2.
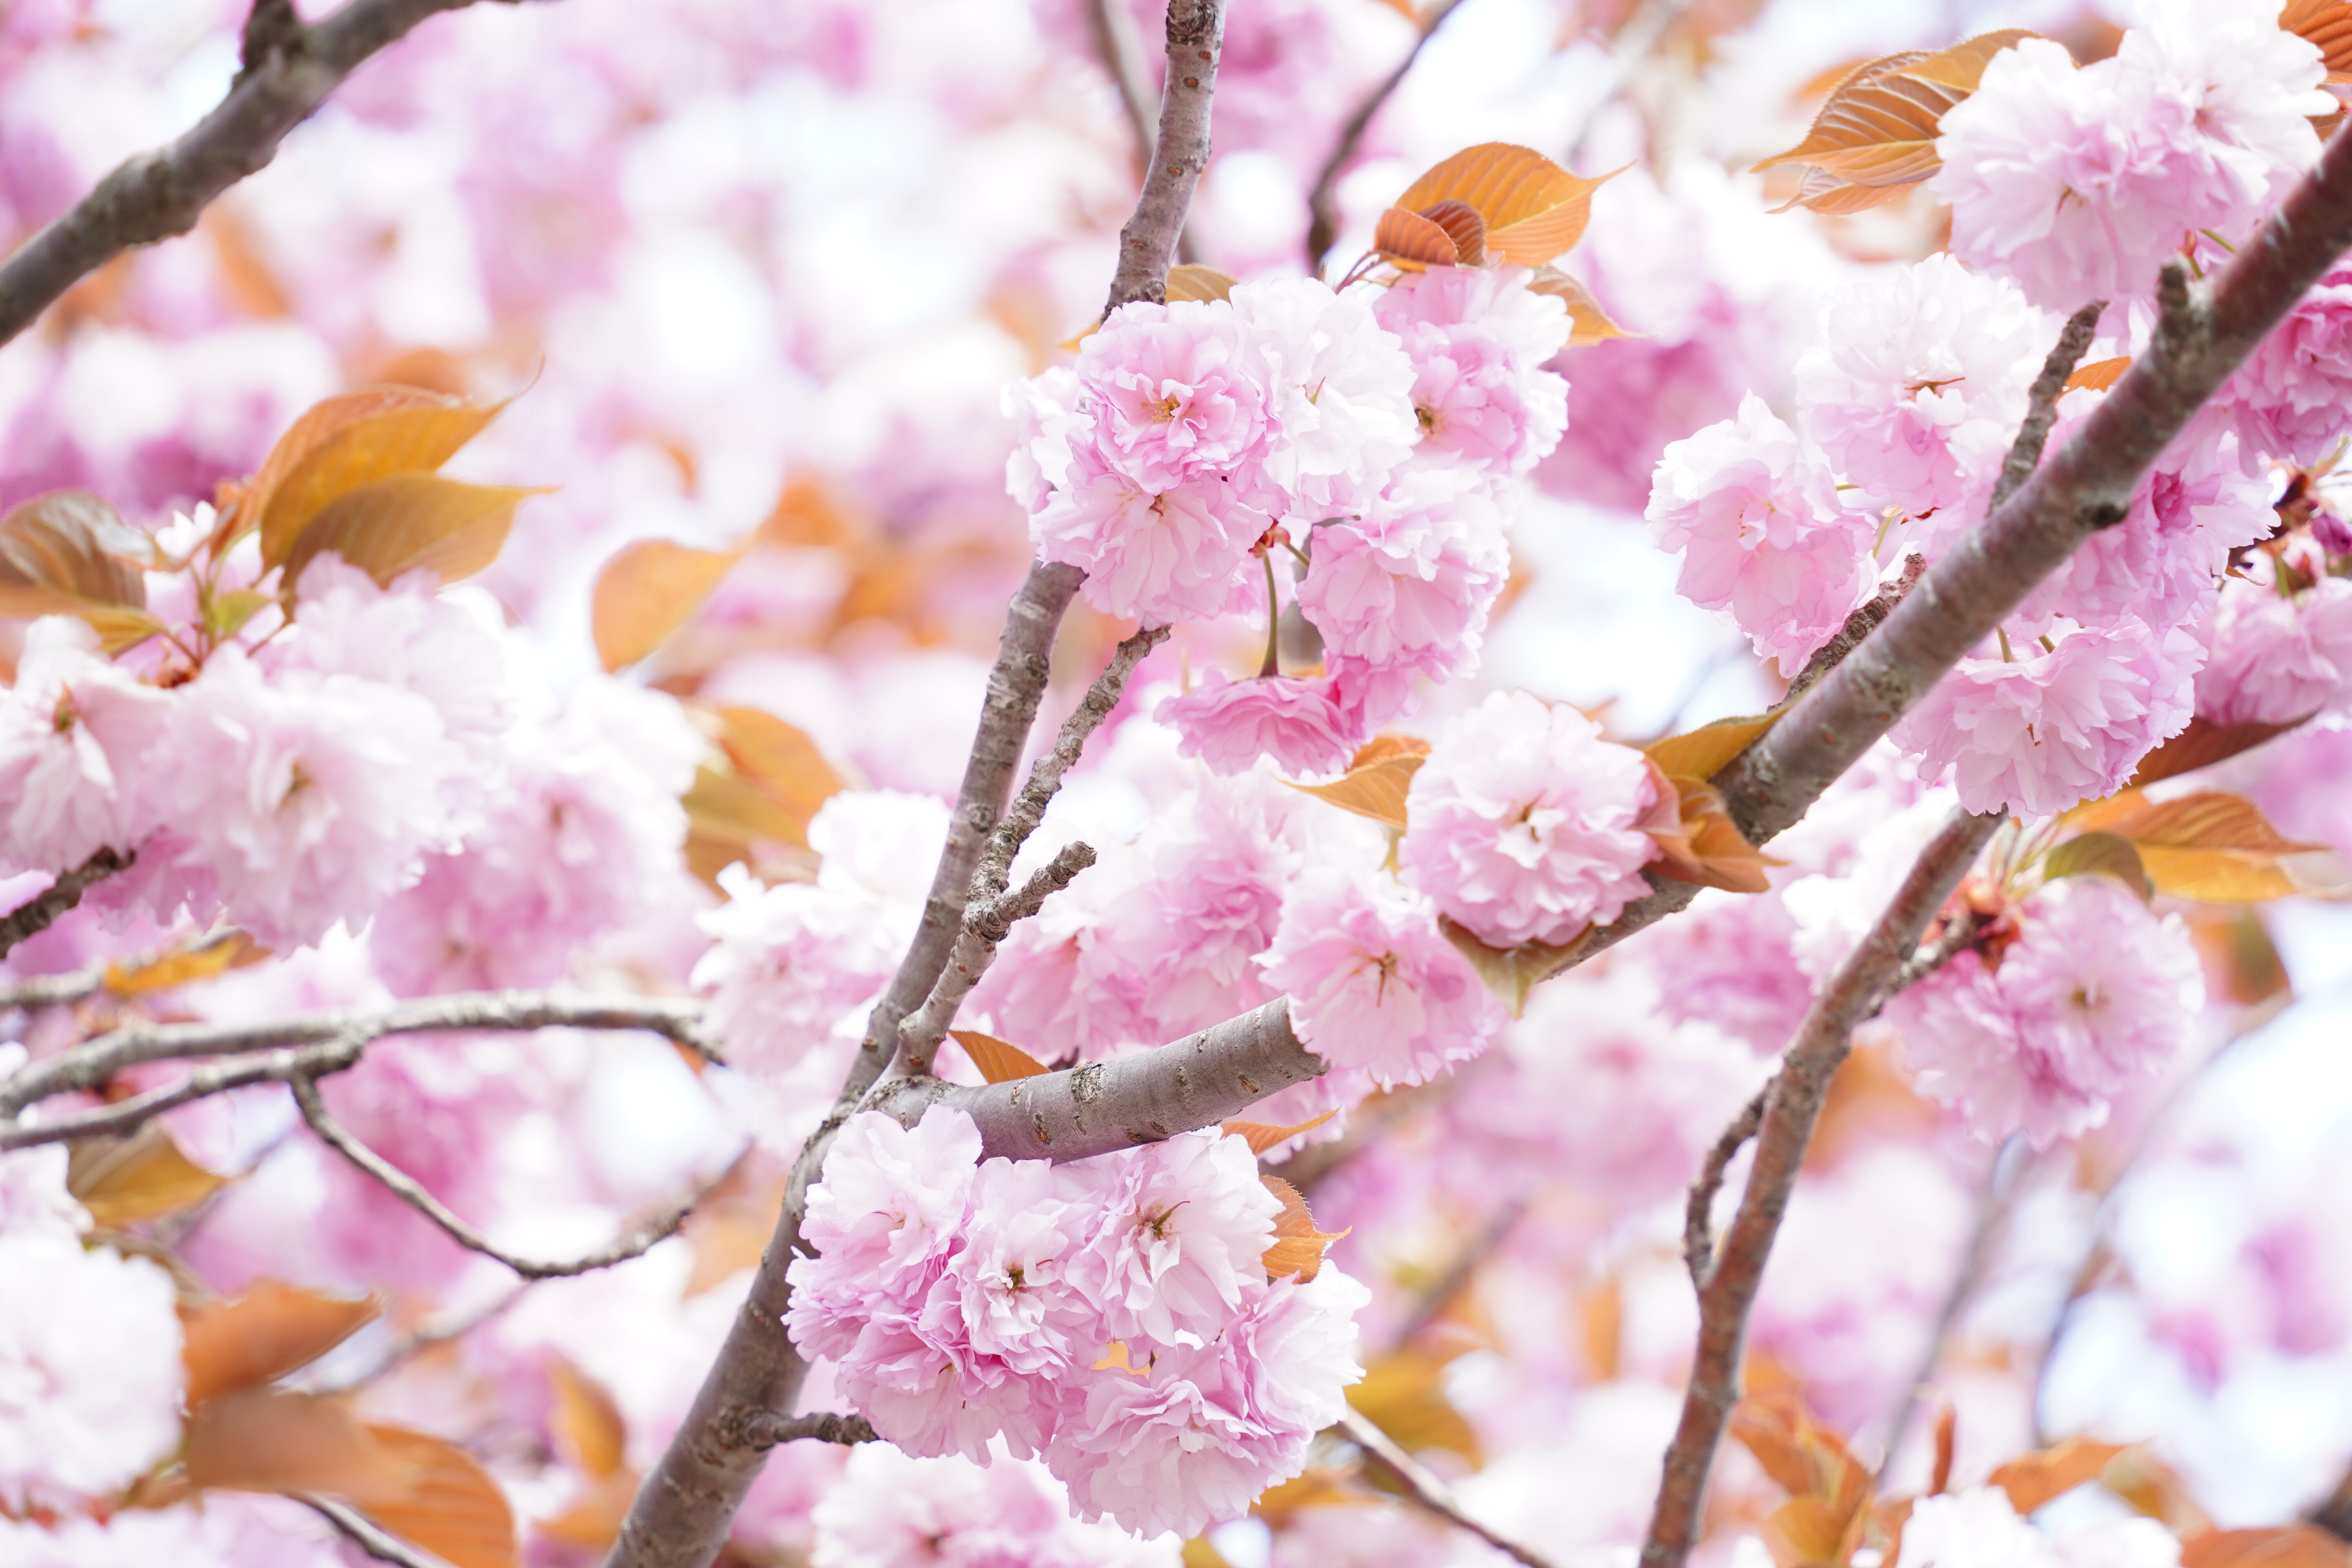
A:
0;0;520;343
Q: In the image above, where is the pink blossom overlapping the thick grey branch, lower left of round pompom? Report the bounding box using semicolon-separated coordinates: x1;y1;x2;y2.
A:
1261;875;1503;1089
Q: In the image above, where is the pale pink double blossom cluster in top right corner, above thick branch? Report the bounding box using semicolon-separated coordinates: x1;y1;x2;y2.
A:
1933;15;2336;310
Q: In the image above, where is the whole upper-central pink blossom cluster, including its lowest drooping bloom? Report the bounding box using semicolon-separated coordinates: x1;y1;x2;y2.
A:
1007;268;1569;773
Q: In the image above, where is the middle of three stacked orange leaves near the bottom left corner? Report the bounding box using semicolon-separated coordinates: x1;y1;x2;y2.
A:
181;1387;409;1504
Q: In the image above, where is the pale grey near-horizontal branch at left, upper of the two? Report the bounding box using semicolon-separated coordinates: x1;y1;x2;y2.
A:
0;992;720;1117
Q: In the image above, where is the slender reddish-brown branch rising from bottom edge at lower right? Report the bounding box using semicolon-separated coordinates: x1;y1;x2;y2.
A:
1642;811;2002;1568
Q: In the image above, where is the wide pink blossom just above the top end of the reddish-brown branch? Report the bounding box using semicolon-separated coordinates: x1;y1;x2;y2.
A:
1889;616;2204;816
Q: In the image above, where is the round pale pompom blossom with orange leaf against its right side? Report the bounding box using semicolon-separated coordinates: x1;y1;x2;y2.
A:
1397;691;1658;947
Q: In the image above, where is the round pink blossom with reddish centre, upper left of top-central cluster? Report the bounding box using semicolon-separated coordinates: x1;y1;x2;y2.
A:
1077;301;1268;491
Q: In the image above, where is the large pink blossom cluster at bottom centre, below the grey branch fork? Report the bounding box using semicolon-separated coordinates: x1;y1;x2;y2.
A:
786;1107;1369;1535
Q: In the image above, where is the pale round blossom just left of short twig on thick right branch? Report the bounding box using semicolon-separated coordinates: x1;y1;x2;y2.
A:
1797;254;2056;526
